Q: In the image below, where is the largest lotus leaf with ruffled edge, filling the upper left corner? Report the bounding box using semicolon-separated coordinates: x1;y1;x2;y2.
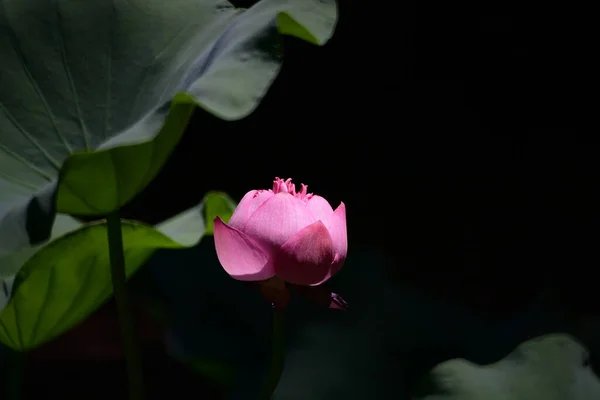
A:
0;0;336;260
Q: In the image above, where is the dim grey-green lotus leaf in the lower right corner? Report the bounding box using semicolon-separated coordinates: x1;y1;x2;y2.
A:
413;334;600;400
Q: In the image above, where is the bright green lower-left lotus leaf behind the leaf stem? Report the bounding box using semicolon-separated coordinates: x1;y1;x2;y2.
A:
0;205;205;351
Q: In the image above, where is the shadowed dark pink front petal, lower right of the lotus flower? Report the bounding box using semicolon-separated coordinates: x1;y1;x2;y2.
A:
274;221;335;285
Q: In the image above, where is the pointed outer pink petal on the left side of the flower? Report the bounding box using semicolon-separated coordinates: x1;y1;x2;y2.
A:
214;217;275;281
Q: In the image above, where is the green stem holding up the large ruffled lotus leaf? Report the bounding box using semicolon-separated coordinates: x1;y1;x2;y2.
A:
107;211;144;400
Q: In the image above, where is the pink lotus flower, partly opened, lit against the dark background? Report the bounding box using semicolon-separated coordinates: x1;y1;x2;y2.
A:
214;178;348;308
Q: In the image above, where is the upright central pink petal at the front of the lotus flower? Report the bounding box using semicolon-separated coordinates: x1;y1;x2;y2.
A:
243;193;316;250
